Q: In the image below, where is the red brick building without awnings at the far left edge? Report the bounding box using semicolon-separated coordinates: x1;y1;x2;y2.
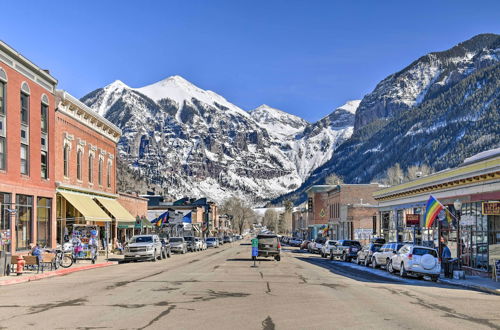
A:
0;41;57;253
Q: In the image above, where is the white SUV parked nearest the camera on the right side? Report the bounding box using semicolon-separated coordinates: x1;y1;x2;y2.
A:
387;244;441;282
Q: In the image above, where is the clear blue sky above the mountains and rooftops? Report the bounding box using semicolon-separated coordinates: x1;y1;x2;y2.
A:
0;0;500;121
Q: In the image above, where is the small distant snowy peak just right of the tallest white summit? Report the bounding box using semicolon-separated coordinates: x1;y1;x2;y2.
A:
249;104;309;139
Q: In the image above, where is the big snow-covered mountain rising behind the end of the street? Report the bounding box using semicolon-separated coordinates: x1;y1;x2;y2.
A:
82;76;354;205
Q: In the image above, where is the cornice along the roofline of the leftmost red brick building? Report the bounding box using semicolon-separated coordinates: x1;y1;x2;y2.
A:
0;40;57;94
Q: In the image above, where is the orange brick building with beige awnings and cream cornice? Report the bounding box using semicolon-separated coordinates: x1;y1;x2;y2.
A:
54;90;135;248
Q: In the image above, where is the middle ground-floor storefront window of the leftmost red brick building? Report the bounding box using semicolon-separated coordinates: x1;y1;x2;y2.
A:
16;195;33;250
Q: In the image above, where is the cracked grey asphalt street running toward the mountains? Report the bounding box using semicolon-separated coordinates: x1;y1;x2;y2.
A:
0;242;500;330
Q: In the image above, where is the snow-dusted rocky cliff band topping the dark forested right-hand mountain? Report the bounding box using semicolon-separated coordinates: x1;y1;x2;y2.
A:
354;34;500;130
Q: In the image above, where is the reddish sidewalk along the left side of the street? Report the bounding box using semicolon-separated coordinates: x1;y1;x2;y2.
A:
0;254;122;286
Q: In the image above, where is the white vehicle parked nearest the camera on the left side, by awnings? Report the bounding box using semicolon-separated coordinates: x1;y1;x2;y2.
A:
123;235;163;261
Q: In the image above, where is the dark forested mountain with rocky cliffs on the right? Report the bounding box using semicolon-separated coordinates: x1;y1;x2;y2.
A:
273;35;500;208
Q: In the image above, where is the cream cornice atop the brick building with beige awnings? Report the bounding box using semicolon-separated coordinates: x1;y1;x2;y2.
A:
56;90;122;143
